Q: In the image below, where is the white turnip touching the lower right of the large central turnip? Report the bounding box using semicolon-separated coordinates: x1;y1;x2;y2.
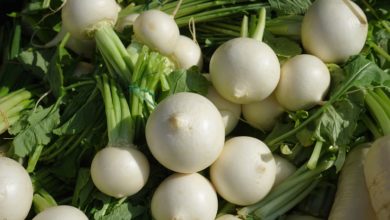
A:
210;136;276;206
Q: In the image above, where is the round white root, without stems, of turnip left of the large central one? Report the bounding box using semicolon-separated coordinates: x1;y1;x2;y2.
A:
91;146;149;198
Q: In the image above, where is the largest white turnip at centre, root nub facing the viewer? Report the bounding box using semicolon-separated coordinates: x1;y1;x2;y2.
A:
145;92;225;173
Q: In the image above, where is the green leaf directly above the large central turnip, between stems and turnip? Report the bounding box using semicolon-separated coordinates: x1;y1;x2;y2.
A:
164;67;209;97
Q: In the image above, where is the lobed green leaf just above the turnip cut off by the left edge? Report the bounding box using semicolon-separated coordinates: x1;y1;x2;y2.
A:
13;104;60;157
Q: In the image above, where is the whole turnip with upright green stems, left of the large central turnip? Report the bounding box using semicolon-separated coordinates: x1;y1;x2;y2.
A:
91;75;149;198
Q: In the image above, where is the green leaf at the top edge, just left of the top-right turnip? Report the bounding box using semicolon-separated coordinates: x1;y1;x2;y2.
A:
268;0;311;15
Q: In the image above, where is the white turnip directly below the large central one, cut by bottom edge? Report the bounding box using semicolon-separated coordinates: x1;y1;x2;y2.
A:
151;173;218;220
